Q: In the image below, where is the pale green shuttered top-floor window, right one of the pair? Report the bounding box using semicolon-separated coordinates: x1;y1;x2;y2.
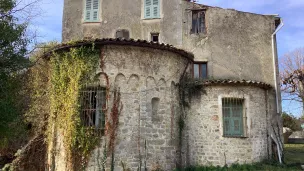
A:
144;0;160;19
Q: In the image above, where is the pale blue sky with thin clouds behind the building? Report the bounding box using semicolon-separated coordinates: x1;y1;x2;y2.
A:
27;0;304;116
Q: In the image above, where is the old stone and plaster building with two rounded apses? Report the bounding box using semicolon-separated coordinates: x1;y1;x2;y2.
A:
47;0;283;170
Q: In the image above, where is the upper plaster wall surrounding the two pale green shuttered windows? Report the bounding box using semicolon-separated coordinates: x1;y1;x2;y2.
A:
62;0;182;47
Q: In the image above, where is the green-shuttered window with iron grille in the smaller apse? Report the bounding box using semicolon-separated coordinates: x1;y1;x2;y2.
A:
222;98;244;137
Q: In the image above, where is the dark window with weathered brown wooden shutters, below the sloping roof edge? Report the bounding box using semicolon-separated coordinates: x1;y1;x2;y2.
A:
191;11;206;34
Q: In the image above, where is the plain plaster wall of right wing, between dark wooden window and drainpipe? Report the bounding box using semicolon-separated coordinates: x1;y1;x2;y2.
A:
183;2;275;85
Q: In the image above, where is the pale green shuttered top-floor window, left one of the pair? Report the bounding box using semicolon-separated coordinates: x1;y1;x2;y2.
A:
84;0;100;22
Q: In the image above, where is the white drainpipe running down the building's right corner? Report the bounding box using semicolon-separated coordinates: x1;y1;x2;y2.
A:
271;18;284;113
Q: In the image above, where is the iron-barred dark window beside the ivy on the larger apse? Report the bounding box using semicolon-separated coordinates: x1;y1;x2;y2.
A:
81;86;106;129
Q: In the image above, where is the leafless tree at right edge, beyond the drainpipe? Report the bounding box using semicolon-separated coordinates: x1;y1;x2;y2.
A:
280;48;304;116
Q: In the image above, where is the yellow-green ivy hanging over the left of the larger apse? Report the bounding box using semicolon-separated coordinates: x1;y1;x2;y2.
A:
47;46;99;170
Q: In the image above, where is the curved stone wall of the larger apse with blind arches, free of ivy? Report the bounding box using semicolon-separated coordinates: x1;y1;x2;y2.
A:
88;45;189;170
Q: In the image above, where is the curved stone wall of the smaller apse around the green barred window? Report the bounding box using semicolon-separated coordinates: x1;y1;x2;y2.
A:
183;86;274;165
